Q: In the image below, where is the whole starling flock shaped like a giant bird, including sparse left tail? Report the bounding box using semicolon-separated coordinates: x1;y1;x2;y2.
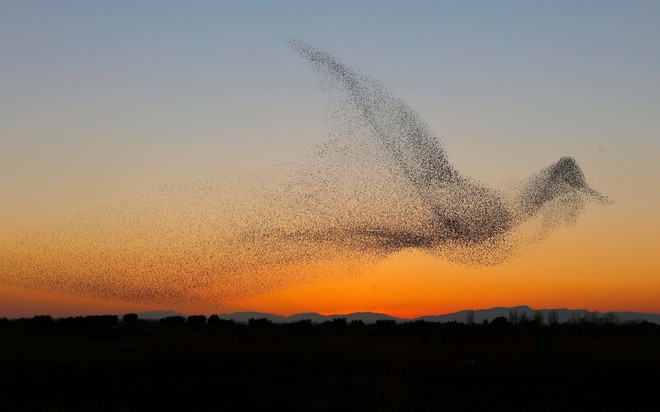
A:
0;40;609;304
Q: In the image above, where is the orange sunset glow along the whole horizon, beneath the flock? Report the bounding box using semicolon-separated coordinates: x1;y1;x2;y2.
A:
0;204;660;318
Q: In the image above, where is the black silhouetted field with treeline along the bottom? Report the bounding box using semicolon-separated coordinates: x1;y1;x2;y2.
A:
0;316;660;411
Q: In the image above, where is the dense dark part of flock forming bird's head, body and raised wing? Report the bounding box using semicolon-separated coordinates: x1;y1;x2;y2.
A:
287;38;611;256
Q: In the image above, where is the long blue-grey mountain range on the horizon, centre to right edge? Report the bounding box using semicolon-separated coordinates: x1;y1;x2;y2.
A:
215;306;660;324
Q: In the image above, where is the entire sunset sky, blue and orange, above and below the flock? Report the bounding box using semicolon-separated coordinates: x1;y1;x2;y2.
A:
0;1;660;317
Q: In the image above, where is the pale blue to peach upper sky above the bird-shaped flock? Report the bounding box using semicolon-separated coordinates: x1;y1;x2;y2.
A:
0;1;660;227
